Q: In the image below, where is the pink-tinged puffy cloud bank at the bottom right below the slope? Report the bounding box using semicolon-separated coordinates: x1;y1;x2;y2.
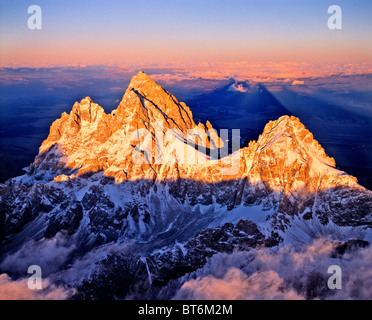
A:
174;240;372;300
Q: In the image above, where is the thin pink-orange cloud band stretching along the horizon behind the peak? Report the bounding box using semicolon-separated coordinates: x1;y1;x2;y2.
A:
0;61;372;87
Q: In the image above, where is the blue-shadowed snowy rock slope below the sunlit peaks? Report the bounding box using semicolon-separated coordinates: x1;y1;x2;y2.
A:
0;173;372;299
